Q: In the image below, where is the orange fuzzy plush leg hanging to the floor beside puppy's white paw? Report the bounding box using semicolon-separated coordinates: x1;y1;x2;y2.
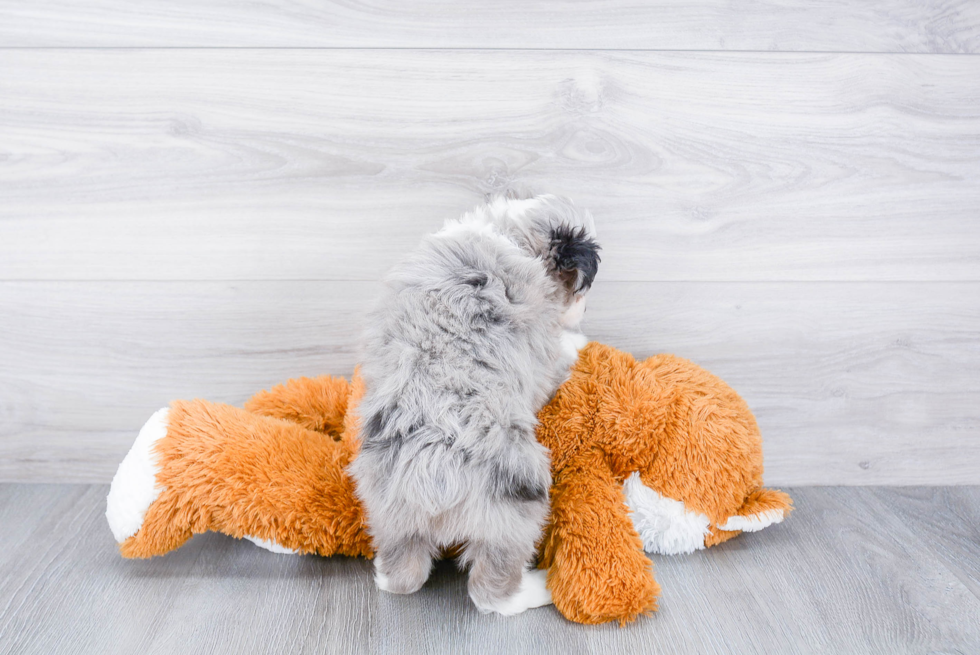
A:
540;452;660;624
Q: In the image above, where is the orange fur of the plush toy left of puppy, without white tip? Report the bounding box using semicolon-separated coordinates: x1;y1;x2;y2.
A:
120;378;373;557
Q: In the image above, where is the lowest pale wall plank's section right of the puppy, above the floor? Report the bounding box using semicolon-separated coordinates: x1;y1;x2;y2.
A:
587;283;980;484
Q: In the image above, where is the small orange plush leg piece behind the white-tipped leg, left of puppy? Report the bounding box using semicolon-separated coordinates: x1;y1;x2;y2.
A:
245;375;351;438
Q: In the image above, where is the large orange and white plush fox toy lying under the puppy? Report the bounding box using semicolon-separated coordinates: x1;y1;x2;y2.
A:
106;343;792;624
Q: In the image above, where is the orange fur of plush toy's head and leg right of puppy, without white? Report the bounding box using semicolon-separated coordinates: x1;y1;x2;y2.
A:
538;342;792;623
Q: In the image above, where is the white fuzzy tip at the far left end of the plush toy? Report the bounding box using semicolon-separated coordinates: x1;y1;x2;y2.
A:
105;407;170;543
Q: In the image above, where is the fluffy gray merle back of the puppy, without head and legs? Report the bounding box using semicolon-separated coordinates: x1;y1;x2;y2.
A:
352;229;561;529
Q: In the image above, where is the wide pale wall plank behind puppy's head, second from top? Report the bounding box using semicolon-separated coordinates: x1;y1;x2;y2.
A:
0;49;980;281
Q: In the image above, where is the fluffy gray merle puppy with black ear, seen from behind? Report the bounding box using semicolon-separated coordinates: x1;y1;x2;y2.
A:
350;196;599;614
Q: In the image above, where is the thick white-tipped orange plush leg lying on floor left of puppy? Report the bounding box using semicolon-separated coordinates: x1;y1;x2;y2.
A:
106;400;372;557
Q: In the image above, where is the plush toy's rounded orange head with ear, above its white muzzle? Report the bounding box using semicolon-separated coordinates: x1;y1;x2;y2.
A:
538;343;782;524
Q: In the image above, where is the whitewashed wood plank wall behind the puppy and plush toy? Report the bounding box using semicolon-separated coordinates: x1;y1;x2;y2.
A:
0;0;980;485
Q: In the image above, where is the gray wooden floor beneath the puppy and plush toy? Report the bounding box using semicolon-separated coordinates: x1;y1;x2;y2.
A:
0;484;980;655
